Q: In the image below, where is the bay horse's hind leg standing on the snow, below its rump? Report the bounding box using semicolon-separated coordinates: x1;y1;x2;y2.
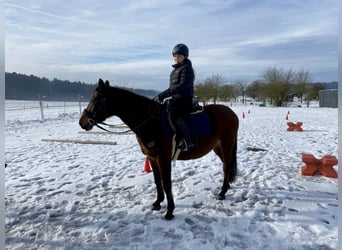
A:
214;142;237;200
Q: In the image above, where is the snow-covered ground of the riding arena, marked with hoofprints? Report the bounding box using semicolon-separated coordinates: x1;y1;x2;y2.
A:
5;101;338;250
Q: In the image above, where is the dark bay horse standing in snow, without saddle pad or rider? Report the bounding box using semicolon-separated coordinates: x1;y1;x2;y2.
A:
79;79;239;220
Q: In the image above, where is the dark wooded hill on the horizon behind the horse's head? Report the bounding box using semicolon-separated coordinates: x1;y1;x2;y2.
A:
5;72;159;101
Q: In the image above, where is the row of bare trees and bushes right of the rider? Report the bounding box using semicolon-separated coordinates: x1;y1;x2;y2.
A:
195;67;337;107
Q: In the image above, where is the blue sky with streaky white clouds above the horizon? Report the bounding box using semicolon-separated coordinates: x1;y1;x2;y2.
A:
4;0;338;90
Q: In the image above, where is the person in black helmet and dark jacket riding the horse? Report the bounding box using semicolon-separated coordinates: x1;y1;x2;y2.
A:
156;43;195;151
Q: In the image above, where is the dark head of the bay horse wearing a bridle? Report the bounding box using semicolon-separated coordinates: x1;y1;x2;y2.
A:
79;79;110;130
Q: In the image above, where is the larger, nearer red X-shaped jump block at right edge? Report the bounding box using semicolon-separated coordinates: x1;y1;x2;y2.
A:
302;154;338;178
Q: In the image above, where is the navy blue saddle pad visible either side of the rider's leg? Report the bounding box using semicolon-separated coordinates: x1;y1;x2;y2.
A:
162;109;211;136
